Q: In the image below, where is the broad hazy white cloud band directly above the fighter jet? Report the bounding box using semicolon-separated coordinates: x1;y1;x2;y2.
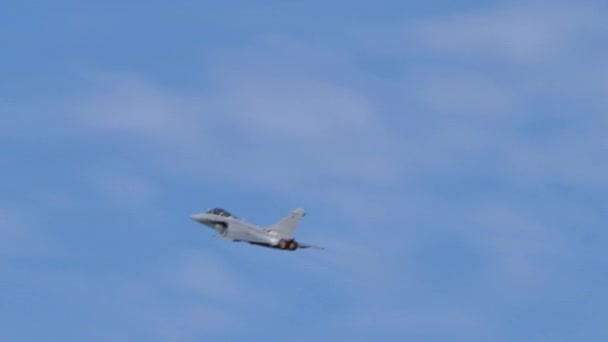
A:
64;66;400;199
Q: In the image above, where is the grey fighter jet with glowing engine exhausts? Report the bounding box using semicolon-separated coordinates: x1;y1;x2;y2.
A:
191;208;323;251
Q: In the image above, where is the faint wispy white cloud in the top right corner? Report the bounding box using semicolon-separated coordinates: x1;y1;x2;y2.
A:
406;2;602;64
